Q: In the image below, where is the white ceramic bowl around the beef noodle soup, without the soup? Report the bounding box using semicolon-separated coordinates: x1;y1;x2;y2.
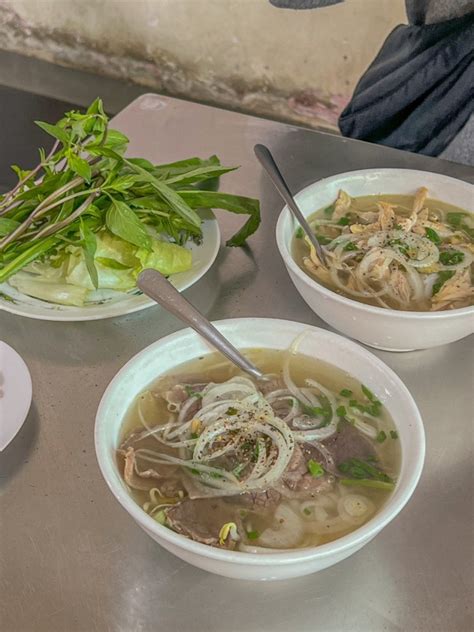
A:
95;318;425;580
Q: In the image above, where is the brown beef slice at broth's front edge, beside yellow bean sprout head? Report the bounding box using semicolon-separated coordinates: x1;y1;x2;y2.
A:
166;498;243;549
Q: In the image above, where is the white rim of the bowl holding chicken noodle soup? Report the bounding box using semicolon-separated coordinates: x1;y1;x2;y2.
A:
275;167;474;320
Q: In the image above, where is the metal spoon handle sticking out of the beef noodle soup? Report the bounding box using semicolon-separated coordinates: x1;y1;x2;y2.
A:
137;269;268;381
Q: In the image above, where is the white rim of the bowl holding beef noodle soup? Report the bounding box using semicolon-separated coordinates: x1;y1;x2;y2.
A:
94;317;426;566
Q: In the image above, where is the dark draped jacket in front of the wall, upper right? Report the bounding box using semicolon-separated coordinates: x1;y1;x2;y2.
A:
270;0;474;156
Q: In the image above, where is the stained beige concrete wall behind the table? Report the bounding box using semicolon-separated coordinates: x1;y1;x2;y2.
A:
0;0;405;126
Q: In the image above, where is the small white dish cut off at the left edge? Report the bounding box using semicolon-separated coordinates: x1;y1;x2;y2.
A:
0;340;32;452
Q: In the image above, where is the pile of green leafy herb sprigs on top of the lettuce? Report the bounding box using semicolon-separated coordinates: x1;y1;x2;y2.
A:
0;99;260;287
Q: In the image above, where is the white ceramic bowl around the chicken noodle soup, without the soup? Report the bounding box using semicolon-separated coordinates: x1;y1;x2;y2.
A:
276;169;474;351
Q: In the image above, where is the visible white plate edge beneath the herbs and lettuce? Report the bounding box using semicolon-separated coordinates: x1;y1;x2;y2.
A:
0;211;220;321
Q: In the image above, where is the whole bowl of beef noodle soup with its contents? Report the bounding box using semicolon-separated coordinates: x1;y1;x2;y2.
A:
95;318;424;579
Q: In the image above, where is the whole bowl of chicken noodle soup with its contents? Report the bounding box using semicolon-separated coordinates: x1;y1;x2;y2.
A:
276;169;474;351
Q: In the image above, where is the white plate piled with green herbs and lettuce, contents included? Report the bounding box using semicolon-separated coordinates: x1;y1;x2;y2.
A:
0;99;260;321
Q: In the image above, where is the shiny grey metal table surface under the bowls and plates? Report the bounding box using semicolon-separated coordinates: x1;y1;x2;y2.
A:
0;91;474;632
